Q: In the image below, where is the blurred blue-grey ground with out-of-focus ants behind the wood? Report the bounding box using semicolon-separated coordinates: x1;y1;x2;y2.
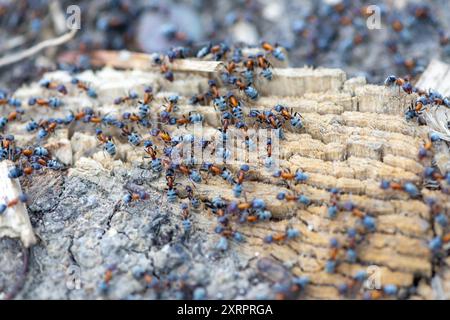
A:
0;0;450;90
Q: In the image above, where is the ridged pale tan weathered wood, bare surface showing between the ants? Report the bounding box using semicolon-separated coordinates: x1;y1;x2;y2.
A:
6;63;450;298
